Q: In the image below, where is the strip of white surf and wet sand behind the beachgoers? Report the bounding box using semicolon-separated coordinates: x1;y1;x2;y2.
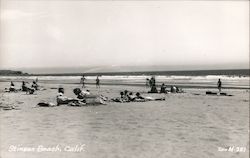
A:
0;76;250;90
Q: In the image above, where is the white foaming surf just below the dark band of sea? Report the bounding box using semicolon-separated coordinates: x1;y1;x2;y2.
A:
0;75;249;83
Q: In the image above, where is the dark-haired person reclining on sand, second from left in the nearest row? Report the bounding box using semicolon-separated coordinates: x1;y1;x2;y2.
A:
73;88;107;105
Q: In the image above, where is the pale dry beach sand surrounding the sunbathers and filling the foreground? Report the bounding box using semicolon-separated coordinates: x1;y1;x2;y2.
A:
0;82;249;158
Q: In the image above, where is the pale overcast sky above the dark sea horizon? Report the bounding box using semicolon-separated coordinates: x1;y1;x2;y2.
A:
0;0;249;68
